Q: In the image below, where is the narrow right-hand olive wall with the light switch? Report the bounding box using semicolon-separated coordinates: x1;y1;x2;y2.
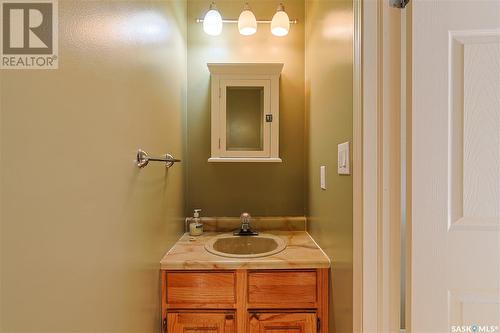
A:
306;0;353;333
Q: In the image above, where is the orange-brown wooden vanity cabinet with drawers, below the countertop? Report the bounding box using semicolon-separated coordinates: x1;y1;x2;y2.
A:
161;268;329;333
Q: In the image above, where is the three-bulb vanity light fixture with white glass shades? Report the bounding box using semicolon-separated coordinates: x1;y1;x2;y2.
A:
196;1;298;37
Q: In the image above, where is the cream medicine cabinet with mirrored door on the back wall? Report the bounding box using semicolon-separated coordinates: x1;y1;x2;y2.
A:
208;63;283;162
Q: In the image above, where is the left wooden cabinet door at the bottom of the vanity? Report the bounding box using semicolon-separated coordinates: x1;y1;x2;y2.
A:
167;312;235;333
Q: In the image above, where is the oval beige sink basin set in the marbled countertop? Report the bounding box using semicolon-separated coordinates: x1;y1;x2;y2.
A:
205;234;286;258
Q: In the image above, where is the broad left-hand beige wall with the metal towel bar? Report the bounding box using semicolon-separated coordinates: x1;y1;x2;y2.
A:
0;0;186;333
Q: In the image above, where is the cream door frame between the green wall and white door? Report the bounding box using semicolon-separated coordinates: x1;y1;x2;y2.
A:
353;0;412;332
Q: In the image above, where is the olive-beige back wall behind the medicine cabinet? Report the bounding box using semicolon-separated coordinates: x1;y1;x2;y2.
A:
187;0;305;216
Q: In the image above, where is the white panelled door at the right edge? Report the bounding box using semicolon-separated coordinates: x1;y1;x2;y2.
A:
411;0;500;332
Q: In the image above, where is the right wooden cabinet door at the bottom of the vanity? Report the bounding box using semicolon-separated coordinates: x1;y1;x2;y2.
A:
249;313;317;333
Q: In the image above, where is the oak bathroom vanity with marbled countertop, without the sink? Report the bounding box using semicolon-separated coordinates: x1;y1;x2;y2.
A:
161;217;330;333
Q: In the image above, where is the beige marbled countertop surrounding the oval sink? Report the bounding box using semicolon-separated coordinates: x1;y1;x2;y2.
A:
160;231;330;270
